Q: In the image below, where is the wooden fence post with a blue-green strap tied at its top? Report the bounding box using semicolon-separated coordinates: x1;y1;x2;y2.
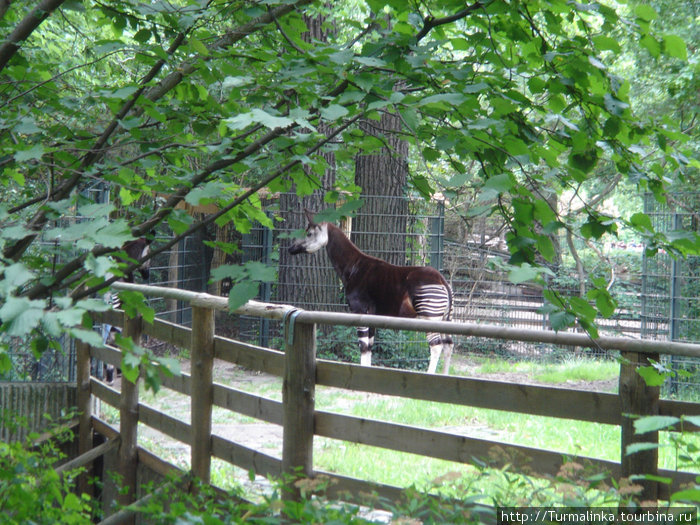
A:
282;313;316;497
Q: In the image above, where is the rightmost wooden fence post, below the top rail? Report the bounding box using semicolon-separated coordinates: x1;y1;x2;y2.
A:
619;352;660;501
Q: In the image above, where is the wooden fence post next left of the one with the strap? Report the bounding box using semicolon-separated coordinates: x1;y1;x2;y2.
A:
191;306;214;483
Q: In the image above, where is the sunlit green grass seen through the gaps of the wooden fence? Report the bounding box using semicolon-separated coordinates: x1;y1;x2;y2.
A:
101;358;700;504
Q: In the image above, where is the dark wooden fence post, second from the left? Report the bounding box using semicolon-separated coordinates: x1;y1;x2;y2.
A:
118;315;142;523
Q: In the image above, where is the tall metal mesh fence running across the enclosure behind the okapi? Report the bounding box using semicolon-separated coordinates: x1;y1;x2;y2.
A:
6;187;700;395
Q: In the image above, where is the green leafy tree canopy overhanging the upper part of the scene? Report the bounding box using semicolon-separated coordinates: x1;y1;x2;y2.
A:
0;0;700;380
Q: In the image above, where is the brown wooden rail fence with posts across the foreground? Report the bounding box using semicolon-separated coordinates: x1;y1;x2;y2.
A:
72;283;700;516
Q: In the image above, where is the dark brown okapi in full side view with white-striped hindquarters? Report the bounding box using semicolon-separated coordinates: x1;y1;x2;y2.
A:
289;210;453;374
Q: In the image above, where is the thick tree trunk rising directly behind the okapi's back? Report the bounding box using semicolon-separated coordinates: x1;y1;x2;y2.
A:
352;107;408;265
